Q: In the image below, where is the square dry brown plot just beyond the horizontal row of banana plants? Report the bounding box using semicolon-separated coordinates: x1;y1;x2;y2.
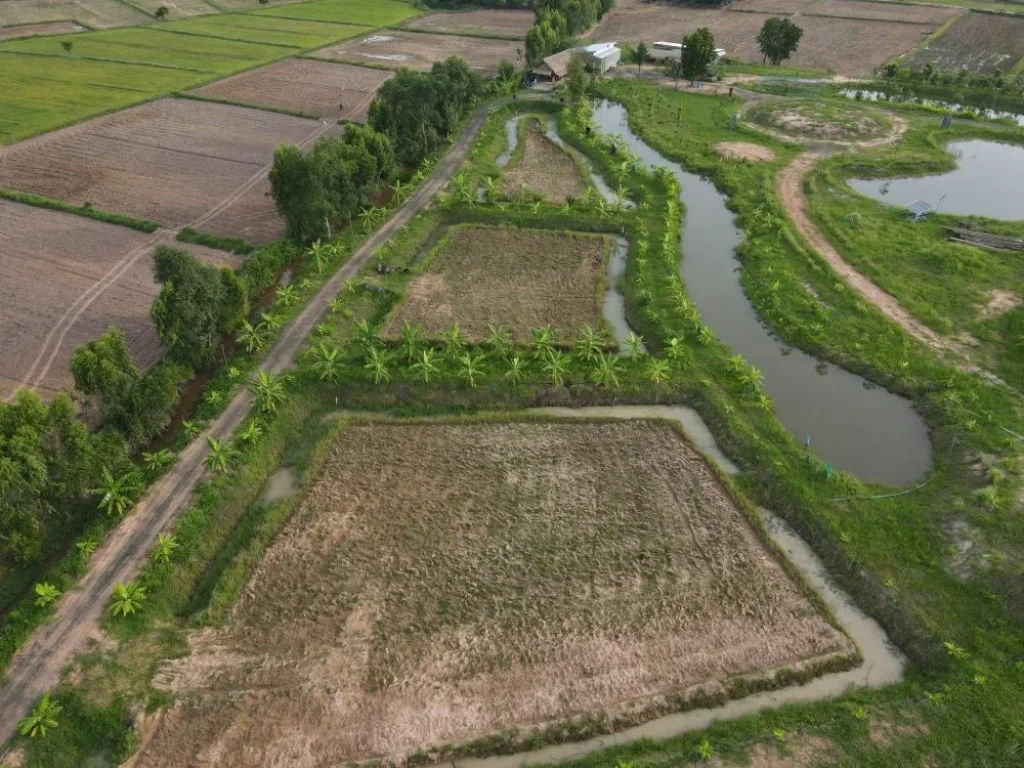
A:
387;226;607;341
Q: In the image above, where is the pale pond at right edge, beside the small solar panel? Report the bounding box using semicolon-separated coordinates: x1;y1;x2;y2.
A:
847;139;1024;219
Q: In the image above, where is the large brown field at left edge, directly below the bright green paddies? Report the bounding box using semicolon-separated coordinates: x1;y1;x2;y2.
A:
0;99;339;243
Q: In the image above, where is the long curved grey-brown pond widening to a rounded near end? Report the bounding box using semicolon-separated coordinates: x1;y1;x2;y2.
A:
594;101;932;485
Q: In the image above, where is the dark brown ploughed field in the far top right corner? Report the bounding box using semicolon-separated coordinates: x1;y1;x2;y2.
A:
910;13;1024;73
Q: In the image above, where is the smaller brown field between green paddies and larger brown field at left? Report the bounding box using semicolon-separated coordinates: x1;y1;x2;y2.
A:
193;58;391;122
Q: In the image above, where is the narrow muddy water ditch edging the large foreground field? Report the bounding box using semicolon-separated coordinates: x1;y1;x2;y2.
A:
454;406;905;768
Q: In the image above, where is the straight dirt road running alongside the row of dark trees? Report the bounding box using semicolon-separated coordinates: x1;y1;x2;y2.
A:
0;100;489;759
